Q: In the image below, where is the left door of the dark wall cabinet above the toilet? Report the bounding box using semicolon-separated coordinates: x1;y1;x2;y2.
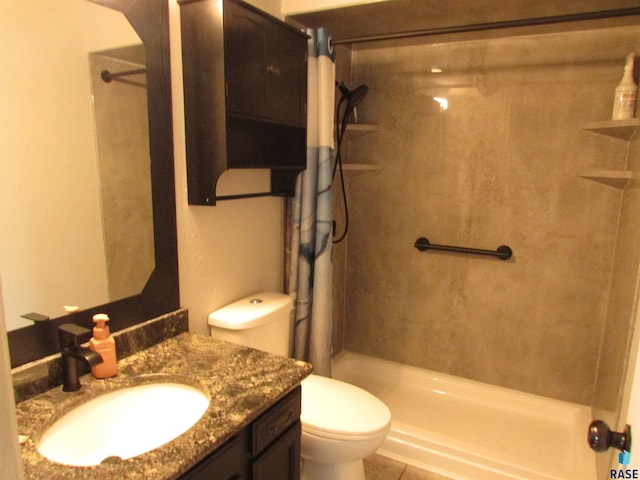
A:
224;1;268;118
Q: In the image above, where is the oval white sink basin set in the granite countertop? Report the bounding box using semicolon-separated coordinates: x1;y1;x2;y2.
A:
37;376;209;466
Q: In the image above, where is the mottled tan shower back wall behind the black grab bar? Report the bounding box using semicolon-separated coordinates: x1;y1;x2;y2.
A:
340;27;638;404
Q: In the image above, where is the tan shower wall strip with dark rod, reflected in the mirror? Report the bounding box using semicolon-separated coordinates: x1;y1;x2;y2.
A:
89;43;155;305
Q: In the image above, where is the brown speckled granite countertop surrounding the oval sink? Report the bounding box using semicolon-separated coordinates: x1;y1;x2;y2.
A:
16;333;312;480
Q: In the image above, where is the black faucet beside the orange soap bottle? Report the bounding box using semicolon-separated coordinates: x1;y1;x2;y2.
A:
58;323;102;392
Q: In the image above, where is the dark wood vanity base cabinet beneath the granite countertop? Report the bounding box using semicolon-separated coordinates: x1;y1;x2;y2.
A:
180;387;301;480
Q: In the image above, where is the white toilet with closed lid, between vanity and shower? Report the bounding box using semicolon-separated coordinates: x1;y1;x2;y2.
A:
209;292;391;480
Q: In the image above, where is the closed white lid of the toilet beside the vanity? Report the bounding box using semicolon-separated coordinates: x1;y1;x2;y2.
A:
300;375;391;436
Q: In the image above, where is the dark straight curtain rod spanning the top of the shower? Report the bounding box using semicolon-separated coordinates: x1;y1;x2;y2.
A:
333;7;640;45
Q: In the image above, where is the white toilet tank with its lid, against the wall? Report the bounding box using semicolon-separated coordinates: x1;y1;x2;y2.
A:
209;292;293;357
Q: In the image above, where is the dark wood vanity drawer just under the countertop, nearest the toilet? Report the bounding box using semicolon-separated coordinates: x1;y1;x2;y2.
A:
251;387;301;455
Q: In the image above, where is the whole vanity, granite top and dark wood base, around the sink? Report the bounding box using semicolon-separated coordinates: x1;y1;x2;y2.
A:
16;333;312;480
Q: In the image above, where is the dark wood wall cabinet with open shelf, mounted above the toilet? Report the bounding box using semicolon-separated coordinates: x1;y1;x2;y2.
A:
178;0;307;205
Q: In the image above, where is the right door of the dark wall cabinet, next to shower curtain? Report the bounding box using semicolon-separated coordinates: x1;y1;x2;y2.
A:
266;24;307;126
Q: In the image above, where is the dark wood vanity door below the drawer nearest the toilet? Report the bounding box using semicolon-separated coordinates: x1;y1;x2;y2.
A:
252;422;302;480
